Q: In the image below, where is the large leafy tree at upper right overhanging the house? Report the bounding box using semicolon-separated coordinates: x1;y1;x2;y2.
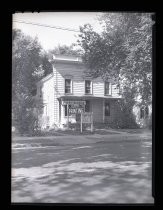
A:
78;13;153;104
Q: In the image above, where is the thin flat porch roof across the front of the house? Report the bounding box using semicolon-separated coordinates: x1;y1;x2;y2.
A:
58;95;123;101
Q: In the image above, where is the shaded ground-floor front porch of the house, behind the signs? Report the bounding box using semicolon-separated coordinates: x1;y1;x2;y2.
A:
58;96;119;125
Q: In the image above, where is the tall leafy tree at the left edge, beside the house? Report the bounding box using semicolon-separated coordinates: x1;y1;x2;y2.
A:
12;30;44;133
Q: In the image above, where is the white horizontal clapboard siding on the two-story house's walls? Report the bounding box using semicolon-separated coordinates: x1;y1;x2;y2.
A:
37;60;119;126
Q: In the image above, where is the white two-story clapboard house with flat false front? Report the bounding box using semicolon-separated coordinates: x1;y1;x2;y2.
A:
37;55;121;128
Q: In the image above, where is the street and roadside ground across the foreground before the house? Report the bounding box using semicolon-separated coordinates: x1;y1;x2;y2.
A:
12;128;153;203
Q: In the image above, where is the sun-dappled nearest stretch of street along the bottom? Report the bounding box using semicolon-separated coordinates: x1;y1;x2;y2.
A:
12;155;152;203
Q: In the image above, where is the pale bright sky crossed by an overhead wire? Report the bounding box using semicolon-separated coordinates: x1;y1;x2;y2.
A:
13;12;102;50
